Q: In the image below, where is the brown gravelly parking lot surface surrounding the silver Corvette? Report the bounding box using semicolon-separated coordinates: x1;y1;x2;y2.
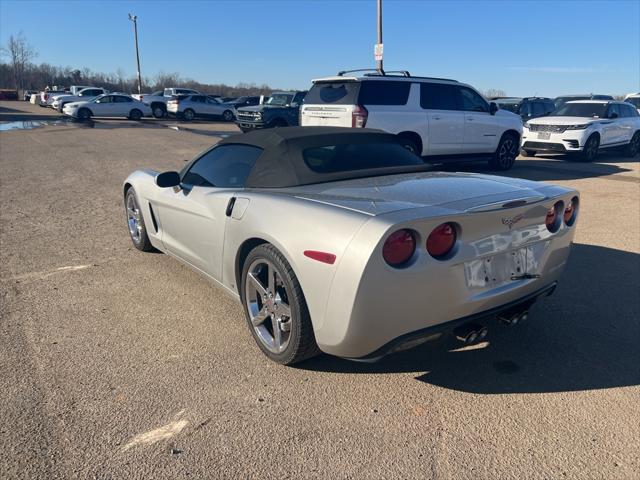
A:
0;102;640;479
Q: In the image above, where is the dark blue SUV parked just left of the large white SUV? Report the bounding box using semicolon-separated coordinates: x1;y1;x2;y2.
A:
236;91;307;132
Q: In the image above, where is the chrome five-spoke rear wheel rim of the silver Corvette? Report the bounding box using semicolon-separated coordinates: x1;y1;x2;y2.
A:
244;258;291;353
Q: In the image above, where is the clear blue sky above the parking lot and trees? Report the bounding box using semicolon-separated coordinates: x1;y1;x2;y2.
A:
0;0;640;96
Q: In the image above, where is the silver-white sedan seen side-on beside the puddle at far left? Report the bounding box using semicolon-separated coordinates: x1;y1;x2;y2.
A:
62;93;151;120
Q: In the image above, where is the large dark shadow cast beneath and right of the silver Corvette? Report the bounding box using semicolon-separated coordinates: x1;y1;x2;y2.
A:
299;244;640;394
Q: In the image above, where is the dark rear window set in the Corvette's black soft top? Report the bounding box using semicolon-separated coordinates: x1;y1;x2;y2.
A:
302;143;424;173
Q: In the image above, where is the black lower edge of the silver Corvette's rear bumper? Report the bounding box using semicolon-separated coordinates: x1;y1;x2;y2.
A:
352;282;558;362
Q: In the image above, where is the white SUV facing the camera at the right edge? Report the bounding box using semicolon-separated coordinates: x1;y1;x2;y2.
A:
522;100;640;162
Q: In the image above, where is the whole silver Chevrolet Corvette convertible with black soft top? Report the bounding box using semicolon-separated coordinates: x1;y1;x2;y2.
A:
123;127;580;364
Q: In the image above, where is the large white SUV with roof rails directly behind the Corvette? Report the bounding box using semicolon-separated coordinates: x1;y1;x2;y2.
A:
300;72;522;170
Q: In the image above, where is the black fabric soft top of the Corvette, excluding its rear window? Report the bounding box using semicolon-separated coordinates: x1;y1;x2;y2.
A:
218;127;429;188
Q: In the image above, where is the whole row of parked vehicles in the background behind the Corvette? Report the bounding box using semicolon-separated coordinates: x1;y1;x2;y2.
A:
22;74;640;165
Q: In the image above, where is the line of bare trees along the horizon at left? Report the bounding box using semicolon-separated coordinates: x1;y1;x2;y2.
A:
0;33;274;97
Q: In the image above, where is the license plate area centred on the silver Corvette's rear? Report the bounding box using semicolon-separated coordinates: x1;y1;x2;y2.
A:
464;248;529;289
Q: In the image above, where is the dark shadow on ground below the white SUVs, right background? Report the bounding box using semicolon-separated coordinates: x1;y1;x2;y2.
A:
434;155;640;183
